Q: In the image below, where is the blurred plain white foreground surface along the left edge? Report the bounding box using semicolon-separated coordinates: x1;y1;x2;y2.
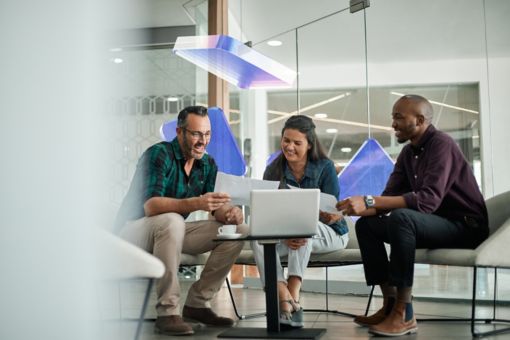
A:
0;0;127;340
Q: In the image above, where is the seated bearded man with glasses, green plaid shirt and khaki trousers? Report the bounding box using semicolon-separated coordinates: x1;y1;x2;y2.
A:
116;106;247;335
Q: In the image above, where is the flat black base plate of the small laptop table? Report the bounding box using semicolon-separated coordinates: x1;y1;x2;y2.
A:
218;327;326;339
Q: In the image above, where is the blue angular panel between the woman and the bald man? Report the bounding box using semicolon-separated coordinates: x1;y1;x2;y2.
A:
338;138;394;200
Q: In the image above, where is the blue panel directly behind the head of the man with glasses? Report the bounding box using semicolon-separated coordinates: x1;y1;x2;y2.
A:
160;107;246;176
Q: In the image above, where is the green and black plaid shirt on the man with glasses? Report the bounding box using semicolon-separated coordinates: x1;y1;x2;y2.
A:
115;138;218;230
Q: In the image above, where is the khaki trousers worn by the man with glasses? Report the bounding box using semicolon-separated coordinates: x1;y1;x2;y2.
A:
119;213;248;316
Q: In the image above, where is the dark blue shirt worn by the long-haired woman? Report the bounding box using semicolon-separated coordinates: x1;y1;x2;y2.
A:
264;159;349;235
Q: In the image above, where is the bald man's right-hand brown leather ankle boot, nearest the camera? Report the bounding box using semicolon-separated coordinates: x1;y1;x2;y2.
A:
369;301;418;336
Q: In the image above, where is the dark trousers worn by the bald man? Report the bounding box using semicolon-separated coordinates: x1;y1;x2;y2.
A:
356;209;488;287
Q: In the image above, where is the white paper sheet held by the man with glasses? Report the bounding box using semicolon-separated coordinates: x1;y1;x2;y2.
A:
214;171;280;205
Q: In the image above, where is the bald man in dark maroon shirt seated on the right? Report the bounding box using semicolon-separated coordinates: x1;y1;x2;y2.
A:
337;95;489;336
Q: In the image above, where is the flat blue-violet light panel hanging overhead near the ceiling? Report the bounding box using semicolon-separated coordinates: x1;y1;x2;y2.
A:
173;35;296;89
